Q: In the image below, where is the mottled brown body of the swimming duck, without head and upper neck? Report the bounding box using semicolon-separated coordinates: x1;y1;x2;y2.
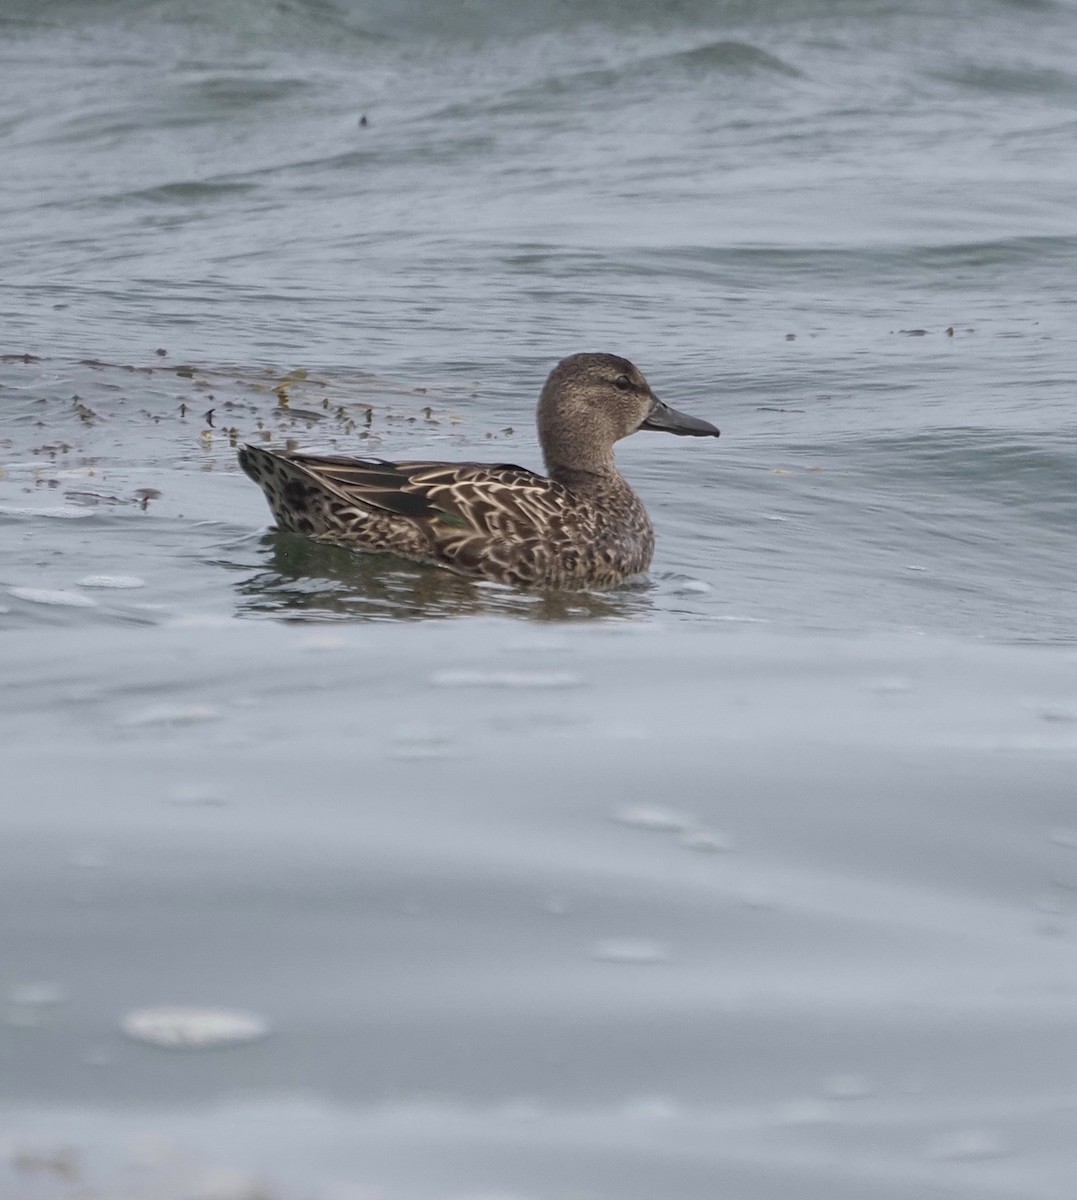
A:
240;446;654;588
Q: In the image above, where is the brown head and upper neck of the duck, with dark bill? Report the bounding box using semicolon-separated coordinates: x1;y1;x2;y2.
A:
539;354;718;472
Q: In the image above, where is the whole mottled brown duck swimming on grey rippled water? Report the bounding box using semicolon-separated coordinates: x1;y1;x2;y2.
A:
239;354;718;590
